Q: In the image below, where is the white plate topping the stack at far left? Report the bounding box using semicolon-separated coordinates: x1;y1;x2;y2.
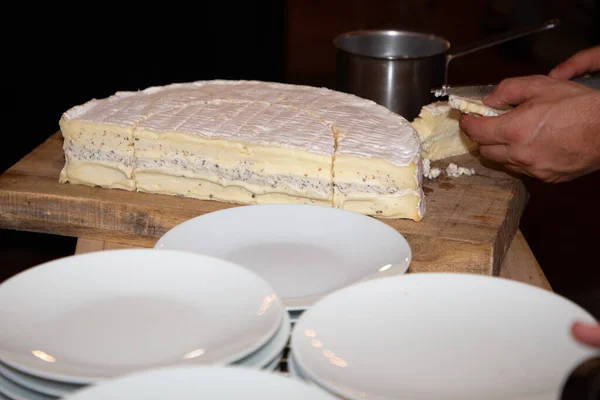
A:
0;249;285;383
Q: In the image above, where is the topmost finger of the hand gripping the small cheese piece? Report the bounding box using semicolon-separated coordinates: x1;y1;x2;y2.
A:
483;75;552;109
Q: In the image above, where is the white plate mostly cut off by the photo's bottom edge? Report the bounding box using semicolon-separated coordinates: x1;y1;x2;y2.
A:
66;366;335;400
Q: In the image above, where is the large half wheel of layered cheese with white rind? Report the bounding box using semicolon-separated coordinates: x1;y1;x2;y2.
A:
60;80;425;220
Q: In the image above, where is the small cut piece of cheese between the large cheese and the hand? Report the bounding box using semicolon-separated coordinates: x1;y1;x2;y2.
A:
412;101;477;161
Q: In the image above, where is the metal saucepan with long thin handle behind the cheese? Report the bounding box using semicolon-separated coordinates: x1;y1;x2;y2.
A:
333;19;559;120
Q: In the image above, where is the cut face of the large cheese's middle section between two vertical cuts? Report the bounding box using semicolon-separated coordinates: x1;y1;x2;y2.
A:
135;130;333;202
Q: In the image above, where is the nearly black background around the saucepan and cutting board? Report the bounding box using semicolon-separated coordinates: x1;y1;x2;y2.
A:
0;0;600;317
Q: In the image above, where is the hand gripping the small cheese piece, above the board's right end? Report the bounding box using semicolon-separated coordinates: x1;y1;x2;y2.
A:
460;75;600;182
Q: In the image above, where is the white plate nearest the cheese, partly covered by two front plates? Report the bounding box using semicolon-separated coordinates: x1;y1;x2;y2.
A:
155;204;411;310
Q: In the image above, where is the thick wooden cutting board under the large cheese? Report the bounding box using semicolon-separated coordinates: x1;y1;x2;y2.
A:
0;132;527;275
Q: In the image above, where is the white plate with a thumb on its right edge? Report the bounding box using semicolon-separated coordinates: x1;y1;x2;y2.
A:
291;273;594;400
